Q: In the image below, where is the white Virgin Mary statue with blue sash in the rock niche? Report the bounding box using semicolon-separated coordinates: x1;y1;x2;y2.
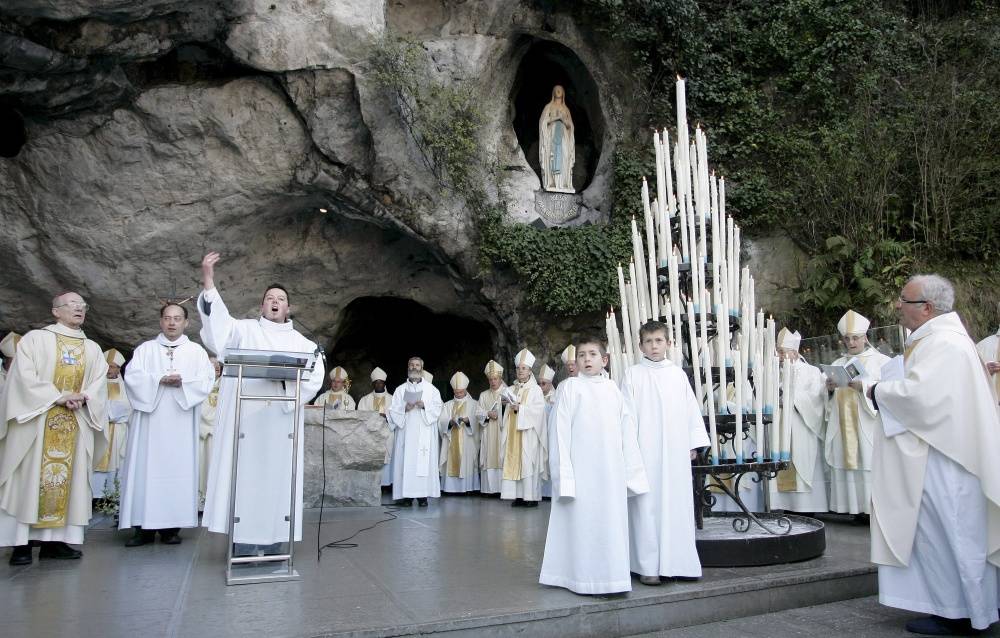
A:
538;84;576;193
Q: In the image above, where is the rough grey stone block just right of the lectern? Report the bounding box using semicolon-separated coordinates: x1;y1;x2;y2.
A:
303;407;389;507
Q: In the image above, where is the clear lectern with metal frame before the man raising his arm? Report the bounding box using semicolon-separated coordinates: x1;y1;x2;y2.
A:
222;349;316;585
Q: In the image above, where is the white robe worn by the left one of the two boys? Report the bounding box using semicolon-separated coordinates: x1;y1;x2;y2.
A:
538;374;649;594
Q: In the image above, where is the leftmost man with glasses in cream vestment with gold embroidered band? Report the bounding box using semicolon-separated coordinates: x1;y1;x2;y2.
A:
0;292;108;565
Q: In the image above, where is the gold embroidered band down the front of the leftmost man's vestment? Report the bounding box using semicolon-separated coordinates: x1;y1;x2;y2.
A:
33;334;87;529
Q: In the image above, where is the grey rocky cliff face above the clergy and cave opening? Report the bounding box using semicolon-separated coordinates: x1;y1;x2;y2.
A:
0;0;627;373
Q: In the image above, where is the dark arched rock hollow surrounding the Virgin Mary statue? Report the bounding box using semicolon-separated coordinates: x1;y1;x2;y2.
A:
511;39;604;192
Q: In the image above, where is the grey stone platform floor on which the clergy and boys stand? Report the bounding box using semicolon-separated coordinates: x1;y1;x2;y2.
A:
0;496;876;638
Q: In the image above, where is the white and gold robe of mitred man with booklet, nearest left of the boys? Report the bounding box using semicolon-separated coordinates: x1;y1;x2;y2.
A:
500;376;549;501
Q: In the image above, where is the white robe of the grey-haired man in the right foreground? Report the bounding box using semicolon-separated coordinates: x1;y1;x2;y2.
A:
871;312;1000;629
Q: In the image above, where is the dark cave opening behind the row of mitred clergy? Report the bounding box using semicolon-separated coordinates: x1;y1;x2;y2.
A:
324;297;495;401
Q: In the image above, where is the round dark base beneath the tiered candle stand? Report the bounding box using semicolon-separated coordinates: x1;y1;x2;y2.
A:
696;513;826;567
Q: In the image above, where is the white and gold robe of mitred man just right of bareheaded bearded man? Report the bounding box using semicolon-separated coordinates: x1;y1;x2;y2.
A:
438;394;480;492
